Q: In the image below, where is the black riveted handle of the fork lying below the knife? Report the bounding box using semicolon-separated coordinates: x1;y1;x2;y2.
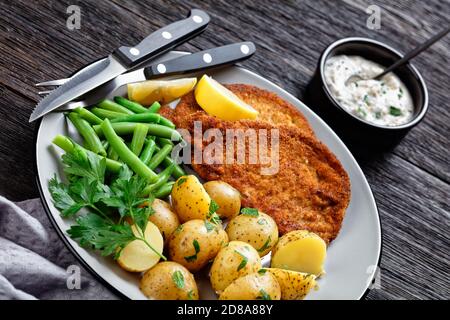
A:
144;41;256;79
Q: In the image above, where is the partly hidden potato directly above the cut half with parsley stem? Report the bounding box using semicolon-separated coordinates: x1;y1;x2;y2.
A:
148;199;180;244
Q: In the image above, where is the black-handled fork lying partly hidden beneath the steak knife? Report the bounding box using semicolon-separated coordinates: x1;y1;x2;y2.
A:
36;42;256;111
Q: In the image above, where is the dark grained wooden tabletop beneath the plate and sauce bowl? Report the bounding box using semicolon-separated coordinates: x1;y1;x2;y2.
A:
0;0;450;299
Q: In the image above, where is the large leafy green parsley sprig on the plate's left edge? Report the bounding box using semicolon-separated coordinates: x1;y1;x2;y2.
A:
49;144;166;260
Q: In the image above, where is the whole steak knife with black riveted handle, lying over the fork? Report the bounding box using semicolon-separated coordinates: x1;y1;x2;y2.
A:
29;9;210;122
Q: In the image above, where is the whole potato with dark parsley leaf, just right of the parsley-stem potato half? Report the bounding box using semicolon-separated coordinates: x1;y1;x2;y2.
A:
168;219;228;272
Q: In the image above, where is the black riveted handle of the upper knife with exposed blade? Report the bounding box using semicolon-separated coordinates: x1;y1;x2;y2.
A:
113;9;210;69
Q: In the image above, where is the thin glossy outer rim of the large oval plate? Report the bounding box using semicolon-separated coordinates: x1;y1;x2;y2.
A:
33;50;383;300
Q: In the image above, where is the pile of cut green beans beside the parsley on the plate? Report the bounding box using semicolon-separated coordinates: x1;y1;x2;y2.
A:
58;97;186;198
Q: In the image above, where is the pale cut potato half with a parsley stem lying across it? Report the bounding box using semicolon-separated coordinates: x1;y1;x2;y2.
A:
117;221;164;272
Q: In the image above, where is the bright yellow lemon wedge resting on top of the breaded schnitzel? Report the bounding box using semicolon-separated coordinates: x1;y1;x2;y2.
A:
195;74;258;121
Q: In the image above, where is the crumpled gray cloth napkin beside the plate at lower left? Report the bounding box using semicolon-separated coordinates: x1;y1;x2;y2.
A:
0;196;117;300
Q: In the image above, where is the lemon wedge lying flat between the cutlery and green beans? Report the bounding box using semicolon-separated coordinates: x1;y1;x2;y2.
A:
128;78;197;105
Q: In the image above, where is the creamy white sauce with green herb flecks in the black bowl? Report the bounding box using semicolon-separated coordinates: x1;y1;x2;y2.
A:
325;55;414;126
